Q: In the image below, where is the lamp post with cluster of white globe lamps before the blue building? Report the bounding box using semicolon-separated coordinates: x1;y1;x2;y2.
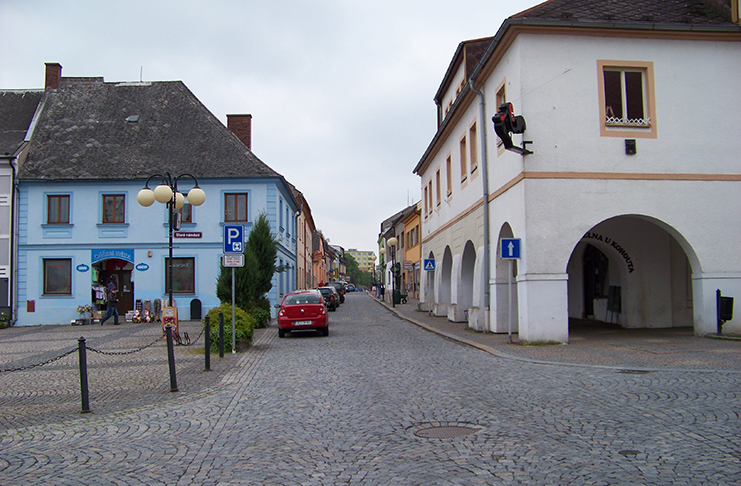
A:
136;172;206;307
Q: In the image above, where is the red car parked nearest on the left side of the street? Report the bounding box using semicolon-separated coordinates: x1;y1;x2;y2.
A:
278;290;329;337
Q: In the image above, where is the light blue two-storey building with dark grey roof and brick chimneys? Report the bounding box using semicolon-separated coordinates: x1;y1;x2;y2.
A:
15;64;298;325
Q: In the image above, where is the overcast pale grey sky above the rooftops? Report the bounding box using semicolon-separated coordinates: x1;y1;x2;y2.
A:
0;0;539;254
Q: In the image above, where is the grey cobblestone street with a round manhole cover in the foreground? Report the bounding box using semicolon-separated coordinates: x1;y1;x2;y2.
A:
0;293;741;485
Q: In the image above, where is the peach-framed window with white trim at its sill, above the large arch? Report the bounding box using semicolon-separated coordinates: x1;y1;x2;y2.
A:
598;61;656;138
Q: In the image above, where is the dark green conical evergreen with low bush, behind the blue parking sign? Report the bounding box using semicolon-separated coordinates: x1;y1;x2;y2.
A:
216;213;277;309
